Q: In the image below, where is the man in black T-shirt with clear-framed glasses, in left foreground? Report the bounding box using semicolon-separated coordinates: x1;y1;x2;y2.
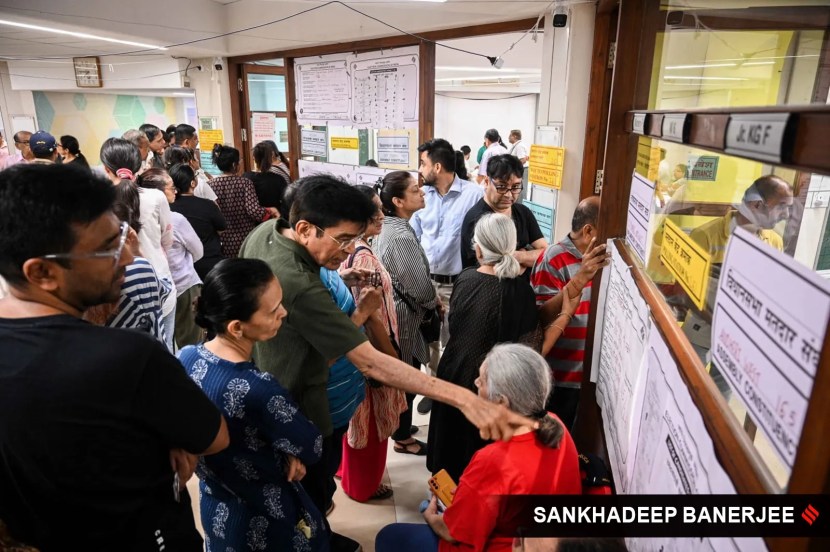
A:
0;164;228;552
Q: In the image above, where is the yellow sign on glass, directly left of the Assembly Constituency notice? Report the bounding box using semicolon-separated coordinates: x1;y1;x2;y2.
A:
660;219;712;310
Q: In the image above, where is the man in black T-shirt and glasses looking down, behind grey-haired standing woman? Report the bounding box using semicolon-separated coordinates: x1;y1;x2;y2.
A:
461;154;548;276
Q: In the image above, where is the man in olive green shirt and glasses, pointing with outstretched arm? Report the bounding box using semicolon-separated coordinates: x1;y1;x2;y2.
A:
240;175;534;544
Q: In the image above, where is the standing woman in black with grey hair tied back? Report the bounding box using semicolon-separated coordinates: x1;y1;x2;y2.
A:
427;213;577;481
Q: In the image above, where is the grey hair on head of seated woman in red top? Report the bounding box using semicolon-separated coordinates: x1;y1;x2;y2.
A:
484;343;552;416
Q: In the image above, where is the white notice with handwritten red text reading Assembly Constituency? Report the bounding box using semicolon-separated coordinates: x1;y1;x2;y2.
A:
712;228;830;468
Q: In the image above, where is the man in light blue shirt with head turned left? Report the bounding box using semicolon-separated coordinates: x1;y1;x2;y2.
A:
409;138;483;414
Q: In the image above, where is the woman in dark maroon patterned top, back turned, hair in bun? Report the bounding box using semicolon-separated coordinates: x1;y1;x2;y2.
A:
210;144;280;258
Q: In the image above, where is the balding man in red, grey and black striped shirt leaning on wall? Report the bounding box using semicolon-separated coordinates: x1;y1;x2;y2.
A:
530;196;608;428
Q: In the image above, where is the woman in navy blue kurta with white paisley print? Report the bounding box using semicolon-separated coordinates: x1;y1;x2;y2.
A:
179;259;329;552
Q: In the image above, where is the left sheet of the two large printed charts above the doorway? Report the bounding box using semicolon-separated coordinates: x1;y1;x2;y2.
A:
294;56;351;124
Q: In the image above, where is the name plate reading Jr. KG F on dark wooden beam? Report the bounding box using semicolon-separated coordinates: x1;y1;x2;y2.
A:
724;113;792;163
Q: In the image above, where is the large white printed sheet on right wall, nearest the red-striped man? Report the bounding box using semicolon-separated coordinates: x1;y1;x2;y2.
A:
594;243;651;493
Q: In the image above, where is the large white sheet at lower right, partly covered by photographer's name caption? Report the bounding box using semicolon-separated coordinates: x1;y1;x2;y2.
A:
627;325;766;552
